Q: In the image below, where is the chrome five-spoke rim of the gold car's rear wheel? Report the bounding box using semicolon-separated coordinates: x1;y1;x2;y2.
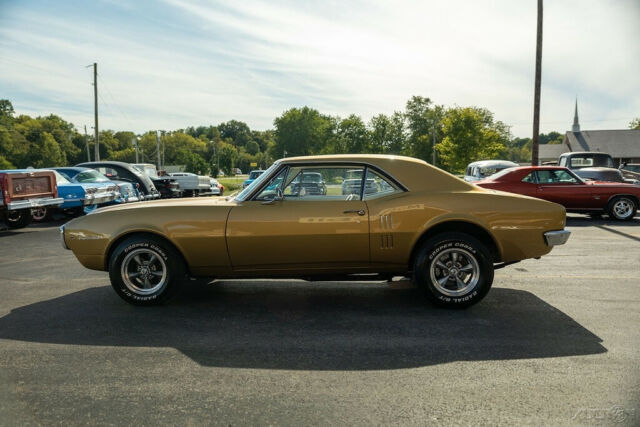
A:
429;248;480;297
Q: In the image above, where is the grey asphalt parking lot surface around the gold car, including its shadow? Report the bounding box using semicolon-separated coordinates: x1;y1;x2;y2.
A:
0;215;640;425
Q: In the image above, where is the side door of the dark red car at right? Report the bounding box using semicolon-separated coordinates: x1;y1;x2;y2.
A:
536;169;593;209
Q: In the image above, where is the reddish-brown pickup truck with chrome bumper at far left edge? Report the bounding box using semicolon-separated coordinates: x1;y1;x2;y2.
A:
0;169;64;229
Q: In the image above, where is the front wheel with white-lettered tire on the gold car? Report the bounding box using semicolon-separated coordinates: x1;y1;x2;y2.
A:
109;235;185;305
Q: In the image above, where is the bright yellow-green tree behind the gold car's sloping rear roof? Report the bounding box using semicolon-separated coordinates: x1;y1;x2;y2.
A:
436;107;509;172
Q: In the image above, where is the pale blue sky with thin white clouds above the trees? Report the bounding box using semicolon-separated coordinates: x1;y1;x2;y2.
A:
0;0;640;136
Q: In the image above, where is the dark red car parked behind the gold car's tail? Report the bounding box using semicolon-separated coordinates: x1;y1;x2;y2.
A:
475;166;640;221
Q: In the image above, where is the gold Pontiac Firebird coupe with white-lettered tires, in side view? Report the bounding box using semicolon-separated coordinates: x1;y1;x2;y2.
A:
60;155;570;307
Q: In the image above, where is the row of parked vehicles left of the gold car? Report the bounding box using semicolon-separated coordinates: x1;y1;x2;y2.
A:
0;161;224;228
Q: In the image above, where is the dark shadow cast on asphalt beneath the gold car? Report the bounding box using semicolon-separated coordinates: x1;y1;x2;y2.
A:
0;281;607;370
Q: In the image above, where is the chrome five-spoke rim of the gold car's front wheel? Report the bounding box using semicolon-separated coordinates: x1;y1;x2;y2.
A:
120;248;167;295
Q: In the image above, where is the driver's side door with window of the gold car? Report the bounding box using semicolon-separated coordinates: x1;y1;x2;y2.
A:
226;165;369;271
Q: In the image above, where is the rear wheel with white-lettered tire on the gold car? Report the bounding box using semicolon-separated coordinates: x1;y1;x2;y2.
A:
414;232;493;308
